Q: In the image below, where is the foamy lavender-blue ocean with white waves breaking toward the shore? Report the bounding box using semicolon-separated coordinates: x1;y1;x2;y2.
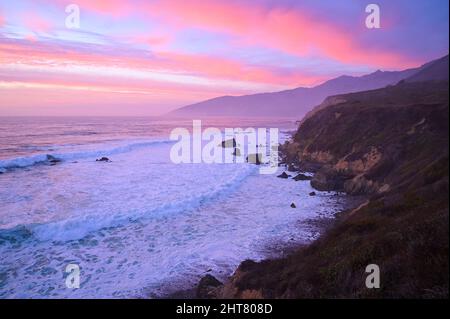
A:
0;117;345;298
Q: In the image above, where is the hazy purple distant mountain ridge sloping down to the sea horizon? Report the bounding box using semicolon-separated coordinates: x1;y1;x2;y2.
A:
169;56;448;118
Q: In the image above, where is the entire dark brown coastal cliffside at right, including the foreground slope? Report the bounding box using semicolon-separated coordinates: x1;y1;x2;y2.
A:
216;82;449;298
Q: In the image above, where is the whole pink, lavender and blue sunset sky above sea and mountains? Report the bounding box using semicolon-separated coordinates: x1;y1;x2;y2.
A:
0;0;449;116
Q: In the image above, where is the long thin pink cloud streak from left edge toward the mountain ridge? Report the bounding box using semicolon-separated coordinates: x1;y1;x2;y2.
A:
0;42;323;87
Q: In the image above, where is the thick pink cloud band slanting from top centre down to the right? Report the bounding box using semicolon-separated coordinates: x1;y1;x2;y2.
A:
145;0;420;68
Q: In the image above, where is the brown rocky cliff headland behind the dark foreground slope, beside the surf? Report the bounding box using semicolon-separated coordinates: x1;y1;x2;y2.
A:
285;82;448;194
